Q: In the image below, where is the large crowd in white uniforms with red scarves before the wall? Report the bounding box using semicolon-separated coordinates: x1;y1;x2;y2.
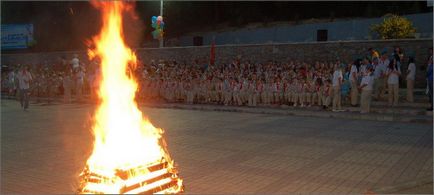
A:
3;47;416;113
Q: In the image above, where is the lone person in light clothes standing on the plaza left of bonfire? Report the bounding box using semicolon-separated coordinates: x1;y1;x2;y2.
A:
17;66;33;110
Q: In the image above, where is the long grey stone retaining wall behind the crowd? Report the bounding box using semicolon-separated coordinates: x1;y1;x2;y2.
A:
1;39;433;88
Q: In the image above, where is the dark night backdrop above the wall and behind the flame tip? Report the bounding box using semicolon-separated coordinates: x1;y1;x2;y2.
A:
1;1;432;52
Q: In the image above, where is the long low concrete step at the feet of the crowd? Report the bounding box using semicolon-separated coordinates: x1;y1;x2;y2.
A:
2;96;433;124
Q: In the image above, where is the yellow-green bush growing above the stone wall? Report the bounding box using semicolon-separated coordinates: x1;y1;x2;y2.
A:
371;14;416;39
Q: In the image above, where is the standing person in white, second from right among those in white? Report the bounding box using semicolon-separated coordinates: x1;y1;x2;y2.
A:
387;59;401;106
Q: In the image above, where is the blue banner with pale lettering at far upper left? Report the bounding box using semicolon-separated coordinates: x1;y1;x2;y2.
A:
1;24;33;49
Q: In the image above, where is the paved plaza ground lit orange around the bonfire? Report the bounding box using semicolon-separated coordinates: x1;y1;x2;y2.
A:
1;100;433;194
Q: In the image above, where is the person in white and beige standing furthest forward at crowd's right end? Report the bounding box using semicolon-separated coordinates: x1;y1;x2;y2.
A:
359;67;374;114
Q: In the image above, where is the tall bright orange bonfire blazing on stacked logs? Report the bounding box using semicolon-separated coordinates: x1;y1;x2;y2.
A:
82;1;182;194
